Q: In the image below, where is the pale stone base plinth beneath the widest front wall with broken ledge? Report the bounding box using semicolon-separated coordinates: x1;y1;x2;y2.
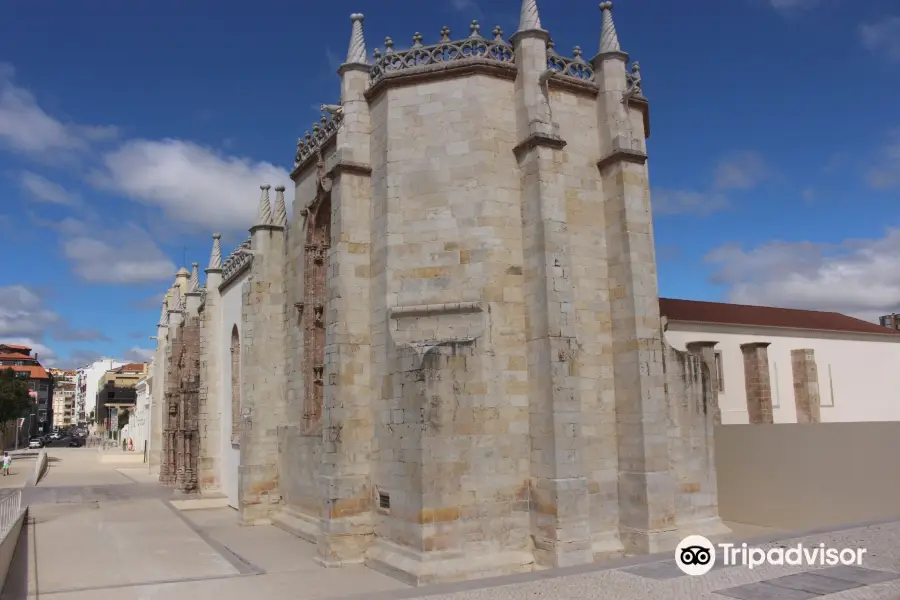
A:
365;539;534;586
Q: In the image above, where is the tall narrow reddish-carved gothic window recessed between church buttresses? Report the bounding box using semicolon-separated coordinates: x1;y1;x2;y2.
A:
302;193;331;427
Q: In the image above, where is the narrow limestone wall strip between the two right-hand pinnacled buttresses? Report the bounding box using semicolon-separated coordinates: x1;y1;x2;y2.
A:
550;83;621;558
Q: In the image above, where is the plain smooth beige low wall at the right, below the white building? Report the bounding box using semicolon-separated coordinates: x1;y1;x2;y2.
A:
715;423;900;530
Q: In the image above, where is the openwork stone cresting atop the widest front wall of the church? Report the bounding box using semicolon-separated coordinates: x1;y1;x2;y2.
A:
369;21;515;85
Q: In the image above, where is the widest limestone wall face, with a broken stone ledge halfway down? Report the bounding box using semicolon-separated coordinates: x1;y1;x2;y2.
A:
362;75;530;578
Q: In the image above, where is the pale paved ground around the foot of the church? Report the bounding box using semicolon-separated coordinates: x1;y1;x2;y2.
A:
2;449;900;600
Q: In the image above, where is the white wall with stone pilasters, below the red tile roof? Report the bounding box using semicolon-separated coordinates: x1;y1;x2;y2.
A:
666;322;900;425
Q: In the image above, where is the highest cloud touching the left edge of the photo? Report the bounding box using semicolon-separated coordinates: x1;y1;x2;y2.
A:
0;63;117;156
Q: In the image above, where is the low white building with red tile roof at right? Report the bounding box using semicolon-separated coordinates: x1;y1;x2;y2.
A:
660;298;900;425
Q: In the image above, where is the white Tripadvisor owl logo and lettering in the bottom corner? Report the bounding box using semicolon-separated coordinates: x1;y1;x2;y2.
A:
675;535;866;575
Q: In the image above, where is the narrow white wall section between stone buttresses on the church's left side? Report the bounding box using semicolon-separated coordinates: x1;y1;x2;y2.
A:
218;272;249;508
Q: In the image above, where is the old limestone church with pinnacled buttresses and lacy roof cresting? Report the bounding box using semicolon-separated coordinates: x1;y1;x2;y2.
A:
149;0;727;584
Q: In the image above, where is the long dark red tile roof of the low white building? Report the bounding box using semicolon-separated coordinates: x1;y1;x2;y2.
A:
659;298;900;335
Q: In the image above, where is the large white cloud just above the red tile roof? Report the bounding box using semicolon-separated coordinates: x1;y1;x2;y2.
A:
706;229;900;321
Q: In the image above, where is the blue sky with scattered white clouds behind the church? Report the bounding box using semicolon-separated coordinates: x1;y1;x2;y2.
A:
0;0;900;366
